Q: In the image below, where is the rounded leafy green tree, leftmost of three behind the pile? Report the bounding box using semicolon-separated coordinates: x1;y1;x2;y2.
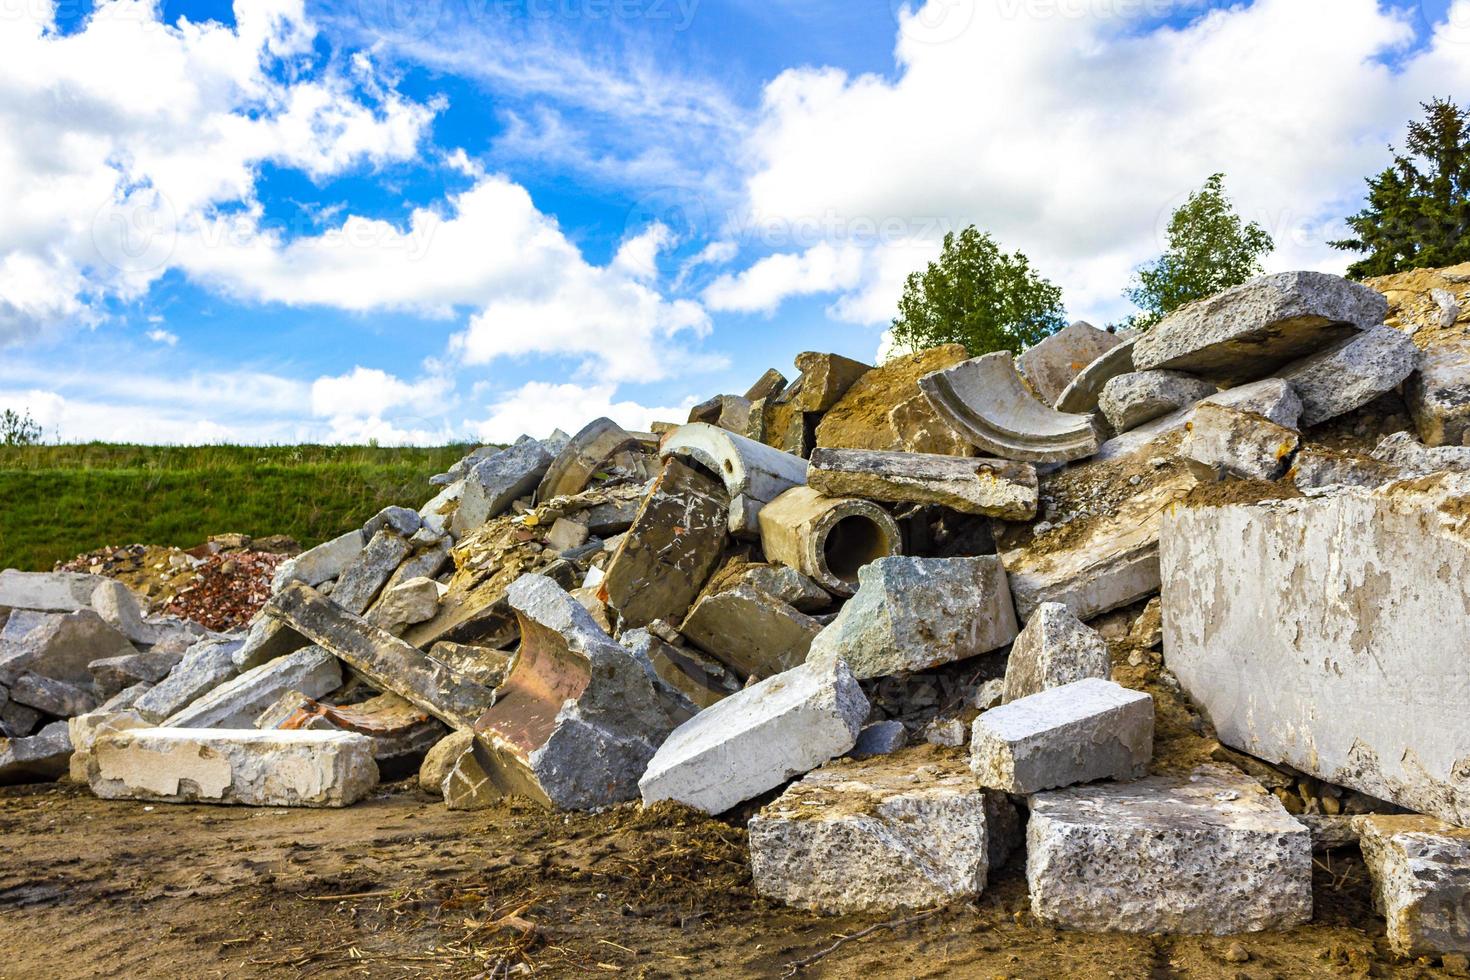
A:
894;225;1066;357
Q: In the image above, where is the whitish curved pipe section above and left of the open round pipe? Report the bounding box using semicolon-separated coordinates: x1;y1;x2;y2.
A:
659;422;807;538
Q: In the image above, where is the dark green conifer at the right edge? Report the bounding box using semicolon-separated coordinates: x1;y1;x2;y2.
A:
1330;98;1470;279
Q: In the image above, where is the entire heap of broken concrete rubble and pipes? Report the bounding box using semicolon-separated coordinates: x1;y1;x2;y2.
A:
0;266;1470;956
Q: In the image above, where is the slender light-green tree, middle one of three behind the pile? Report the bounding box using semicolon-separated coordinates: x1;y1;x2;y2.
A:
1123;173;1276;329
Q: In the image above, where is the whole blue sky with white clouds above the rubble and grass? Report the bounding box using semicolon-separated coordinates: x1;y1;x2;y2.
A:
0;0;1470;444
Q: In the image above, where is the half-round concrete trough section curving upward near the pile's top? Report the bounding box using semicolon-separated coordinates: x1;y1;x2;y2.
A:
919;351;1100;463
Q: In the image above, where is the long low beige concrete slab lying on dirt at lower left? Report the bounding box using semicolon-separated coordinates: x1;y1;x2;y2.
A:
88;727;378;807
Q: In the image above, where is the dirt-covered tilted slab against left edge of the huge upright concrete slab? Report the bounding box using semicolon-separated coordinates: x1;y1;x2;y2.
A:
1001;472;1198;621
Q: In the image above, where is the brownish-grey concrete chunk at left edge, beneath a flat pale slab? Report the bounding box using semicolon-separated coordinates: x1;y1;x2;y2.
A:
0;608;137;688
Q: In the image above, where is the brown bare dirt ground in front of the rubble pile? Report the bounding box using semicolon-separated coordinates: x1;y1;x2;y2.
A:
0;783;1444;980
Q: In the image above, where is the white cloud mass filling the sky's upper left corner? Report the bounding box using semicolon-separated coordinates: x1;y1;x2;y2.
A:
0;0;432;342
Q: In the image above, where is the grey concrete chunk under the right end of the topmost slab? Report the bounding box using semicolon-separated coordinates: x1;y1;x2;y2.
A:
1280;326;1419;428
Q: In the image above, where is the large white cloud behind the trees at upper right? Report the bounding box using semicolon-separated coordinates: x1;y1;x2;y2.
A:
735;0;1470;322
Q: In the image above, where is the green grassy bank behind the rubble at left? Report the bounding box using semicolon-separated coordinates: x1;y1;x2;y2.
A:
0;442;469;570
